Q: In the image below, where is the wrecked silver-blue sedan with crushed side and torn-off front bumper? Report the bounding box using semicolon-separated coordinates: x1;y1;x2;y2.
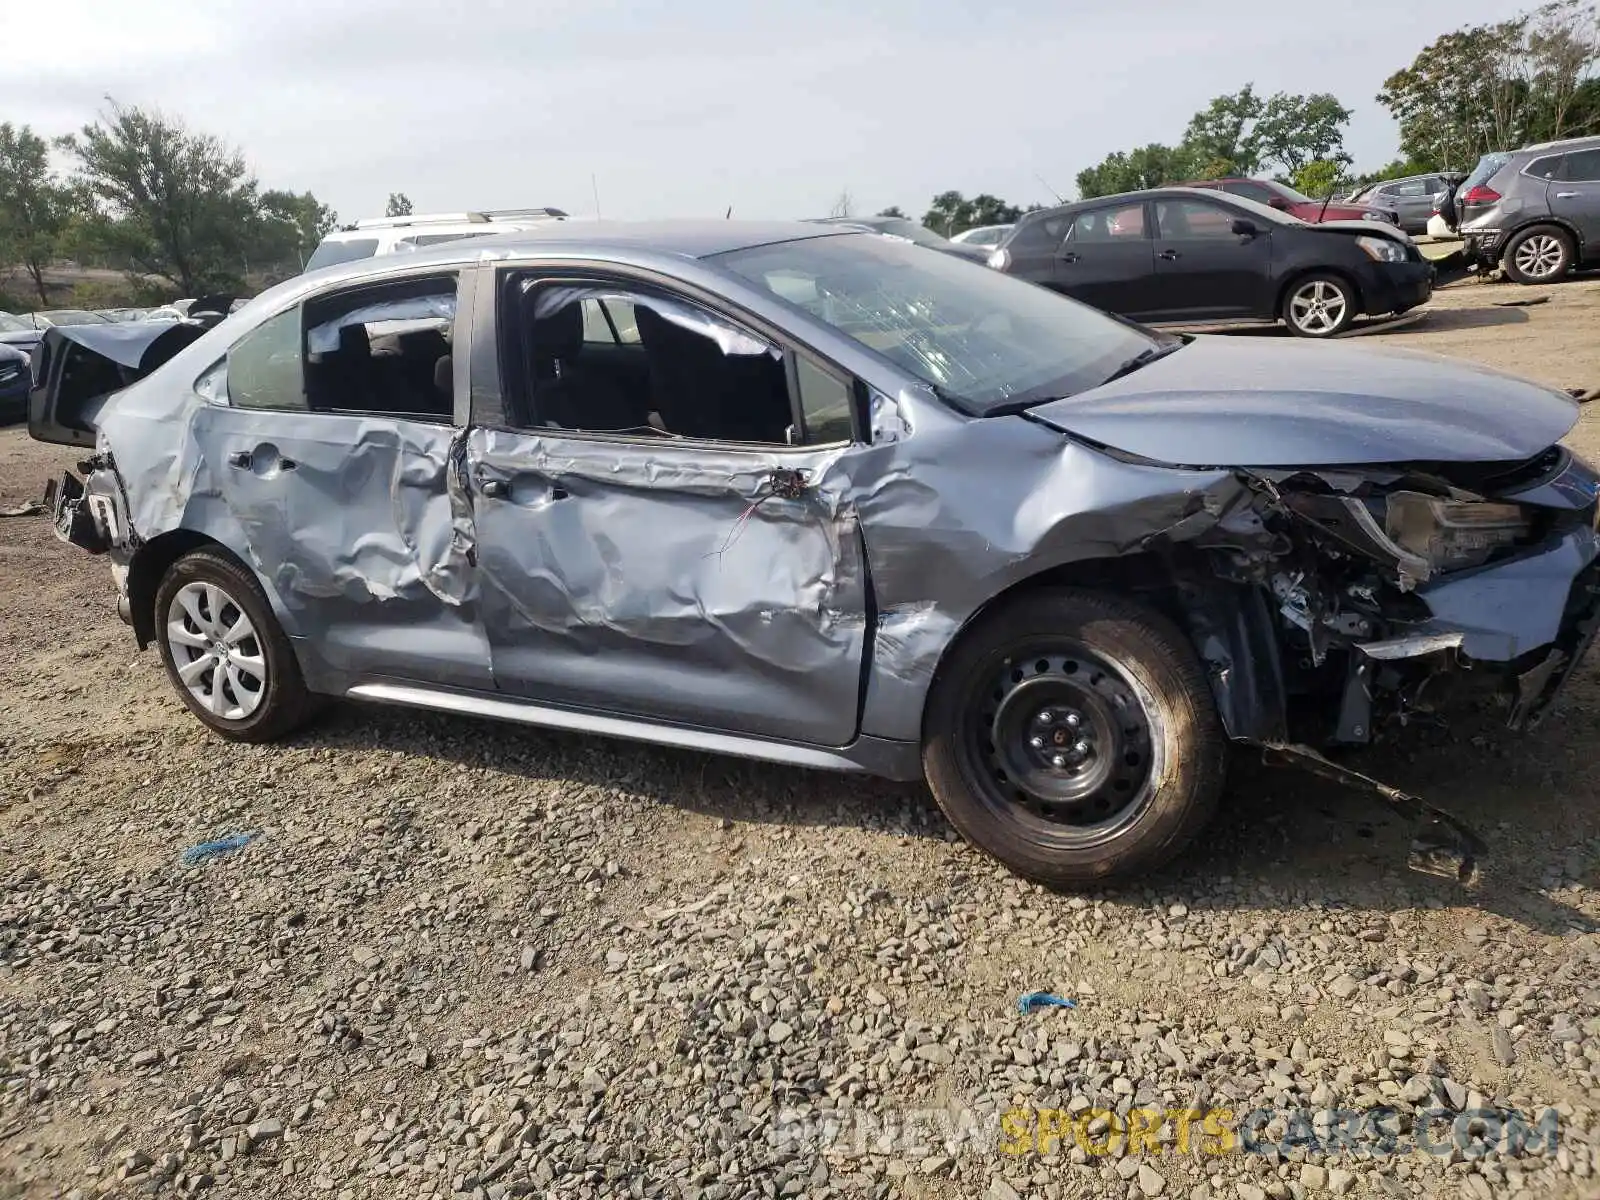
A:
30;221;1600;886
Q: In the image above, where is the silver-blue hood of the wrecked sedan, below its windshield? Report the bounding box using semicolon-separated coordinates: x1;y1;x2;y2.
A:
1027;336;1578;467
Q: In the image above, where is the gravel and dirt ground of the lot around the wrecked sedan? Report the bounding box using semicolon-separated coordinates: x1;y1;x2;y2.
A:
0;282;1600;1200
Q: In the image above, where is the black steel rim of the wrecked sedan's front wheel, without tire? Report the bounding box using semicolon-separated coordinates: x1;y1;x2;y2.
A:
968;640;1152;843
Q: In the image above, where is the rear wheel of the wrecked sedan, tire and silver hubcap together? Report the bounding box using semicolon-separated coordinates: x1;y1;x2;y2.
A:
155;550;317;742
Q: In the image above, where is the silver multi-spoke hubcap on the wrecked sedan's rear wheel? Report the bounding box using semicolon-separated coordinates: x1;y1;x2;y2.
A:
166;584;267;722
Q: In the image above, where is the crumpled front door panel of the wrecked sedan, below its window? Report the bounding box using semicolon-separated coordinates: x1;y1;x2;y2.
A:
467;429;866;746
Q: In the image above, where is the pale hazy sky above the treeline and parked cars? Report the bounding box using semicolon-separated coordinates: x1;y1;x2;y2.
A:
12;0;1518;219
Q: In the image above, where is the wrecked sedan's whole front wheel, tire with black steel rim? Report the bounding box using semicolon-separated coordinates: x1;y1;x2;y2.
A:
923;590;1227;888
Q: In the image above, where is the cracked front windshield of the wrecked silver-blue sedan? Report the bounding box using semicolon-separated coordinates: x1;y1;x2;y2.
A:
714;234;1162;416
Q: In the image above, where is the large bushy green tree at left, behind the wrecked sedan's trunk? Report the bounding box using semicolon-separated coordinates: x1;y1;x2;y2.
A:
61;101;259;296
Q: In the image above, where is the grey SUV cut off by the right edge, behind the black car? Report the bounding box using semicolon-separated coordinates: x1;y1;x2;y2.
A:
1454;138;1600;283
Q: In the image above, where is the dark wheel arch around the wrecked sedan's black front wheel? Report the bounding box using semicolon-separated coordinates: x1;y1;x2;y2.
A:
918;552;1288;752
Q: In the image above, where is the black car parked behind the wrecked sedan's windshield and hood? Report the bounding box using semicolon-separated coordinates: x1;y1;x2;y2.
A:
989;187;1434;338
